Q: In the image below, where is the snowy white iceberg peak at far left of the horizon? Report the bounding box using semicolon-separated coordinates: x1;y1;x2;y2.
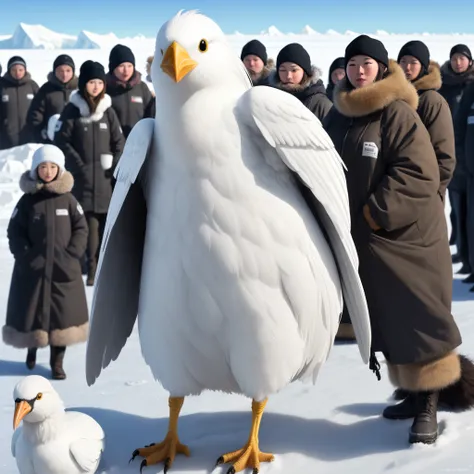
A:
0;23;76;49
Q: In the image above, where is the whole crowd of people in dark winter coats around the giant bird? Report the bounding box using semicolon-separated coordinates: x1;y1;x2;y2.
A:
0;35;474;443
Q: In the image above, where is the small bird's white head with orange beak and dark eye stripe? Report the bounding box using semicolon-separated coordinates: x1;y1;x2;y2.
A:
13;375;64;430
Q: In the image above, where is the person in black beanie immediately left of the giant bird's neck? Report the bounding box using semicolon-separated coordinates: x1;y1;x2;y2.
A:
107;44;155;138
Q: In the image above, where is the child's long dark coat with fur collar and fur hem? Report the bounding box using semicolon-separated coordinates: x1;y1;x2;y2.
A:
3;171;89;348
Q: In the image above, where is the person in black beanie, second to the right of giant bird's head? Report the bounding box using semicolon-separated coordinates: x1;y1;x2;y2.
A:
269;43;332;122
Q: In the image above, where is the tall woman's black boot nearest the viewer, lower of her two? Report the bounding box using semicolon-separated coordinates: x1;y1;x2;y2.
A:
409;391;439;444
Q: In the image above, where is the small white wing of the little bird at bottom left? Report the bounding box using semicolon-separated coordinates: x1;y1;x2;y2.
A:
66;412;105;473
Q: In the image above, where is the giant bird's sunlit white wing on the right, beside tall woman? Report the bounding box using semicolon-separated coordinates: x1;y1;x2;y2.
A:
236;87;371;363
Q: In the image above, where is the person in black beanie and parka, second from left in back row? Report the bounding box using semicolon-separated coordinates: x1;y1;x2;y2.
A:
26;54;77;143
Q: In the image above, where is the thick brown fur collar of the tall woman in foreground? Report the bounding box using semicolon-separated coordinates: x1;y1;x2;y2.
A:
333;59;418;117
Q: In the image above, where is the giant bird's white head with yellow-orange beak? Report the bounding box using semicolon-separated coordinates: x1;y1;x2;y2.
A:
152;10;250;96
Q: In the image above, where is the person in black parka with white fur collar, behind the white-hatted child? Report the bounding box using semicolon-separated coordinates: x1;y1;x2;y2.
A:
54;61;124;286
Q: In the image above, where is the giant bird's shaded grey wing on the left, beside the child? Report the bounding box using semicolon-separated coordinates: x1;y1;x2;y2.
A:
86;118;155;385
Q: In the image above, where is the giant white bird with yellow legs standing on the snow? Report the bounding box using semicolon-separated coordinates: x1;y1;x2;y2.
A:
86;11;371;472
